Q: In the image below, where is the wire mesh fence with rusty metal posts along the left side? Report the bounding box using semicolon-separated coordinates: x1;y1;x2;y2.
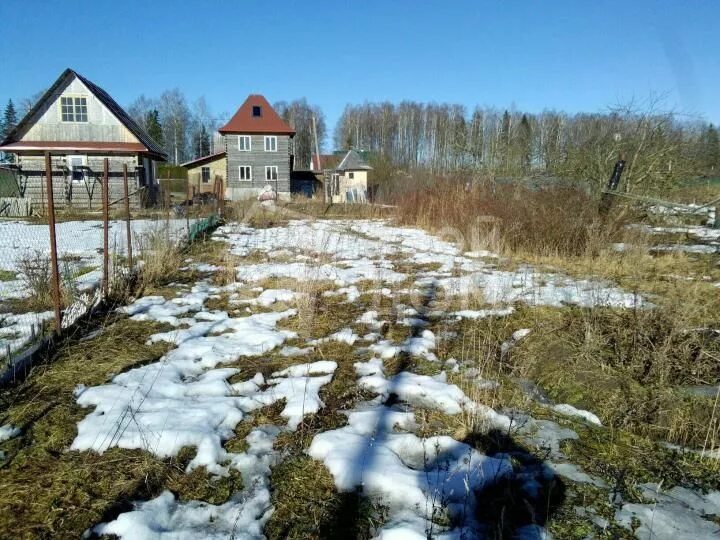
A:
0;158;224;382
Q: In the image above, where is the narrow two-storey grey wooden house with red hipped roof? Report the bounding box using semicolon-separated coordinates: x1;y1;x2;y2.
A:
219;94;295;200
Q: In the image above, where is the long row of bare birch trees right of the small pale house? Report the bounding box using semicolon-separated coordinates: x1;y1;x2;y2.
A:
335;98;720;191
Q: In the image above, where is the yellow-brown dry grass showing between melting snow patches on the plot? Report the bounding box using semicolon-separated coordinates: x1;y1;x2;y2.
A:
0;194;720;539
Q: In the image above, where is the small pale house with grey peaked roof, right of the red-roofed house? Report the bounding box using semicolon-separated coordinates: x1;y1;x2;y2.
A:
311;150;372;203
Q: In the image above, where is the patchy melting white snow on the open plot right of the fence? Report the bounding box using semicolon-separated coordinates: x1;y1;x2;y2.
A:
59;220;720;539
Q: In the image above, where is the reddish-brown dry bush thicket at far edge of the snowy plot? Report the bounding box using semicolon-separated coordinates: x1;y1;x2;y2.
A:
397;182;624;257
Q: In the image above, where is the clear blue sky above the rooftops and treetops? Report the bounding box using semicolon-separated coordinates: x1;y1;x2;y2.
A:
0;0;720;146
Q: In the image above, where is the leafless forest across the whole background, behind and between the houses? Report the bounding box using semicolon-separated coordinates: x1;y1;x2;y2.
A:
0;88;720;196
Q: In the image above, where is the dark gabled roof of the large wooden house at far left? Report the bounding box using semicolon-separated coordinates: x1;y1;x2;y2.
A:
0;68;167;160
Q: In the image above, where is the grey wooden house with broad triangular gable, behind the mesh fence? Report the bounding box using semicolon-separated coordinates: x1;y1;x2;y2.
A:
0;69;166;209
